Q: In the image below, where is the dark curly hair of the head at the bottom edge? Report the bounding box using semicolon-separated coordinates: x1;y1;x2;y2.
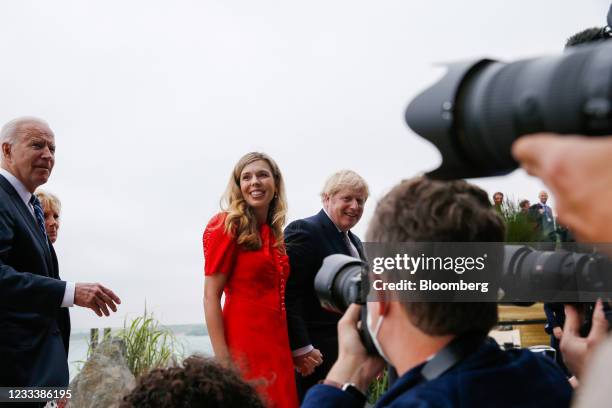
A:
120;356;264;408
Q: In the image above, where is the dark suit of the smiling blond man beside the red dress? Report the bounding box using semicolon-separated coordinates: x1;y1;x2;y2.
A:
285;210;365;398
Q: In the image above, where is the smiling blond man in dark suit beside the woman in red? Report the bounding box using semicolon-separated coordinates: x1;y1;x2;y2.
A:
285;170;369;401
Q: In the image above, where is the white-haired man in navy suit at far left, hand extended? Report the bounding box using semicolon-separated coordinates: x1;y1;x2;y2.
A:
0;117;120;396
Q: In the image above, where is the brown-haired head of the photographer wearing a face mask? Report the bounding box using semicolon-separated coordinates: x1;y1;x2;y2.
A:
367;178;504;373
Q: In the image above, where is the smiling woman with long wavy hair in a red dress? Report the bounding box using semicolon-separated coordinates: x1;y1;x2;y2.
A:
203;153;298;408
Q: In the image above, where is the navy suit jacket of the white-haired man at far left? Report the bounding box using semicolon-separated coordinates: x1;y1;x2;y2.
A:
0;175;70;387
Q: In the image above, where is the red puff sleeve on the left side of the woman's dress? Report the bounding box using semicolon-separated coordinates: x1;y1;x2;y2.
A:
202;213;238;275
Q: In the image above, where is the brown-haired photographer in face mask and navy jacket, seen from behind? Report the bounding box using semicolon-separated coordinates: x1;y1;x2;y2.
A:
303;178;571;407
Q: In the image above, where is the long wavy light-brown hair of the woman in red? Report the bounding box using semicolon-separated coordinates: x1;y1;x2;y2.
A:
221;152;287;253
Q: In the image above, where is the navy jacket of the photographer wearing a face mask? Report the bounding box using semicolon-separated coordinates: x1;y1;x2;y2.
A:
302;341;572;408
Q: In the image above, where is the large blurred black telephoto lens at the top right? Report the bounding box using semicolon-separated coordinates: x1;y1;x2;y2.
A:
405;41;612;179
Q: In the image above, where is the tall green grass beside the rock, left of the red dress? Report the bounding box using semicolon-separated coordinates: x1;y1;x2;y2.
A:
118;309;182;377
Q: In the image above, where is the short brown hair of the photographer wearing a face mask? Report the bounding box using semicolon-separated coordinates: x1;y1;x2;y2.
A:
366;177;505;336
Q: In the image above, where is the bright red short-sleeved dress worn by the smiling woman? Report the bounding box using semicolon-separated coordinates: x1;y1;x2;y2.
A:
203;213;298;408
